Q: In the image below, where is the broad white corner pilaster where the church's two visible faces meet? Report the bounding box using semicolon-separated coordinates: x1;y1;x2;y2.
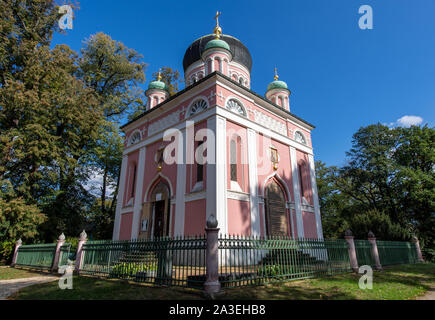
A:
206;116;228;234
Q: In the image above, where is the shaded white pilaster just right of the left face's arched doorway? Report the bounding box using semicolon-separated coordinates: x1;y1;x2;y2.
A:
174;129;187;236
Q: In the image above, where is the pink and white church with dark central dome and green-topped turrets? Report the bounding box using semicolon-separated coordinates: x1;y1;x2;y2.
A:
113;16;323;240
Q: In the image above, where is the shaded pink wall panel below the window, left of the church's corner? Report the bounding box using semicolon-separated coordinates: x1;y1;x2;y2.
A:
184;199;206;236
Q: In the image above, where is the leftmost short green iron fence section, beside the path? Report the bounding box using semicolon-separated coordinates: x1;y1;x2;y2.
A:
16;243;56;269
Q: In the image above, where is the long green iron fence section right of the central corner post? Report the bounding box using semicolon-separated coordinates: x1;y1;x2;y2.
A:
219;236;351;288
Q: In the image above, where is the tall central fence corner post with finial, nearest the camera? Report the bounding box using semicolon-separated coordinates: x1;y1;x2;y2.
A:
204;214;221;299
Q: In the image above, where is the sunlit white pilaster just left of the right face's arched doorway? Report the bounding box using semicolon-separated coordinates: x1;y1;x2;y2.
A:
247;128;261;236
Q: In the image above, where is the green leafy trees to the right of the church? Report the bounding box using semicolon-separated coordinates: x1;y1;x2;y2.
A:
316;124;435;251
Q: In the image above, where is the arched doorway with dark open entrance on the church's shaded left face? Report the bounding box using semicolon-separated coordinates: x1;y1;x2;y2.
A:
139;180;171;238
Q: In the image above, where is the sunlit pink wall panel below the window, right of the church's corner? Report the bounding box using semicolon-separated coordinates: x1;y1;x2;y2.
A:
227;199;251;236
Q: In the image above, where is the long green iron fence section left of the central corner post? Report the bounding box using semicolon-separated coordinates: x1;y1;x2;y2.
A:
80;236;206;288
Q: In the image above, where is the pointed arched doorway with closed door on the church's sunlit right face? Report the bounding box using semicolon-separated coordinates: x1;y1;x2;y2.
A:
264;180;289;237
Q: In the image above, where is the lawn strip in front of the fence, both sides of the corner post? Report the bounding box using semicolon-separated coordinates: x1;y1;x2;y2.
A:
13;263;435;300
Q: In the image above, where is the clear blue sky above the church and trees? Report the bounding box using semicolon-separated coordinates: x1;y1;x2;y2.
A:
54;0;435;165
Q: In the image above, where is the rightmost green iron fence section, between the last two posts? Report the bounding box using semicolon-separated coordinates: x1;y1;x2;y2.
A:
376;240;418;266
